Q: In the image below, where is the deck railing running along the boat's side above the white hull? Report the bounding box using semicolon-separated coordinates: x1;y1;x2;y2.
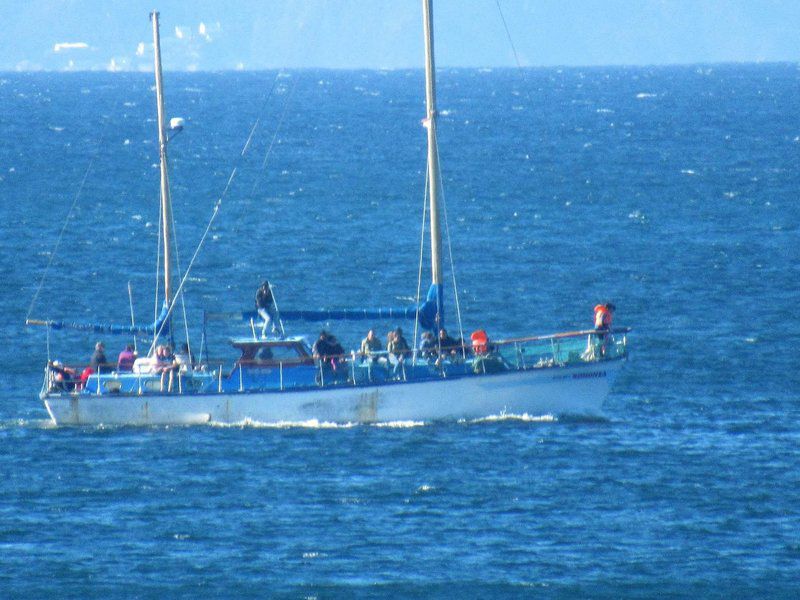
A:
43;328;630;395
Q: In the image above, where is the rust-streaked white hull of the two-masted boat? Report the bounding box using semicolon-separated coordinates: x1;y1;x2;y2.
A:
44;360;622;425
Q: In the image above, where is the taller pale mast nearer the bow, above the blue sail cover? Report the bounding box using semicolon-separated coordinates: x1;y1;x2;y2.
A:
422;0;442;290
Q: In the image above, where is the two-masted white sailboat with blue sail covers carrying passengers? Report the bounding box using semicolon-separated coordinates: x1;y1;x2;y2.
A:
27;5;629;425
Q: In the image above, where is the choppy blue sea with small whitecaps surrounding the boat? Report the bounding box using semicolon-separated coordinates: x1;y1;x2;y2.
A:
0;64;800;598
